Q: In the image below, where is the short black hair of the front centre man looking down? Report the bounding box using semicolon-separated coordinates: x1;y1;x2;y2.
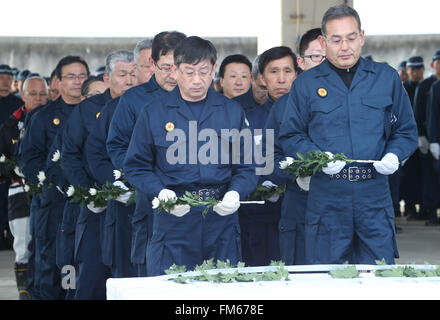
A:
174;36;217;66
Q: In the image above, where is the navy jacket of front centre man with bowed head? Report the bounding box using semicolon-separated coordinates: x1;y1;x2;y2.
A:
124;88;257;199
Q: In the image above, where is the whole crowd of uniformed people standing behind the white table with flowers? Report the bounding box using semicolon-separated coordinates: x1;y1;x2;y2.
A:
0;5;434;299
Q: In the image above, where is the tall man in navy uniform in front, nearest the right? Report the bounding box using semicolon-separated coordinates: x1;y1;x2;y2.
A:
279;5;417;264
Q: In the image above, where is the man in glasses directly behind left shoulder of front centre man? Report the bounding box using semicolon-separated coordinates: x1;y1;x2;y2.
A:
107;31;186;276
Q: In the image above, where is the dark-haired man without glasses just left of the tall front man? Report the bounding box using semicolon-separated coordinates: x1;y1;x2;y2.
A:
239;46;298;266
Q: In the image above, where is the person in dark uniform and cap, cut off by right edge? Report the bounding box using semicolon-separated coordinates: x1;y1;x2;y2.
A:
408;50;440;226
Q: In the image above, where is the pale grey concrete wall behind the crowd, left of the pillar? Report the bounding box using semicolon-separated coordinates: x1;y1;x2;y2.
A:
0;37;257;76
